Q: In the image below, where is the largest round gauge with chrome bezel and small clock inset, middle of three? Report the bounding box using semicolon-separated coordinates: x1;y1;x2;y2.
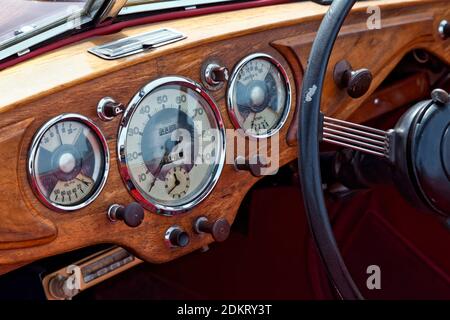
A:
118;77;225;215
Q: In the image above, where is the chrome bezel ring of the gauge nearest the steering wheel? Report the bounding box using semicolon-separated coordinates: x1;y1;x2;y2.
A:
227;53;292;139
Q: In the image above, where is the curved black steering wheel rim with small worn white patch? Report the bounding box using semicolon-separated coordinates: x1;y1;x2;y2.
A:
297;0;363;300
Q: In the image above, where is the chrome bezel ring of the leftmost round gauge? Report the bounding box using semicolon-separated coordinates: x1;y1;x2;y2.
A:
27;113;110;212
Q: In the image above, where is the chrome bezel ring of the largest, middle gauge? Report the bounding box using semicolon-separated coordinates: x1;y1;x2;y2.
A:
117;76;226;216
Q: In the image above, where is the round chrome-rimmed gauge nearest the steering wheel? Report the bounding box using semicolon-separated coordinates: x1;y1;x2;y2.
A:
227;53;291;138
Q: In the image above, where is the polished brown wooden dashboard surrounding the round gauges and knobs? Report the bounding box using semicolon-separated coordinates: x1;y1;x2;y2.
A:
0;0;450;274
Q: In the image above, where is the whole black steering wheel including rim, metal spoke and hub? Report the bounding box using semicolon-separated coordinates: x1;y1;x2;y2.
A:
297;0;450;300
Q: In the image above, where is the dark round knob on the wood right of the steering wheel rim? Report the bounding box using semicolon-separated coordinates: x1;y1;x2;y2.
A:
334;60;373;99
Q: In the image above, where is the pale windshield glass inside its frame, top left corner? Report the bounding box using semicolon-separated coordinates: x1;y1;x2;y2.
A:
0;0;87;43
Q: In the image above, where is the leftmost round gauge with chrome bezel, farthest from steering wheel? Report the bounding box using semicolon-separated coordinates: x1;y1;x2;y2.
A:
28;114;109;211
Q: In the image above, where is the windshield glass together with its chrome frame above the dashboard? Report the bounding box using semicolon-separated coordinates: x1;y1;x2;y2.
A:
0;0;238;63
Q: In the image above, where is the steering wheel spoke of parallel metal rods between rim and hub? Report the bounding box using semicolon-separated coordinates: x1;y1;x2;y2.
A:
322;116;390;158
